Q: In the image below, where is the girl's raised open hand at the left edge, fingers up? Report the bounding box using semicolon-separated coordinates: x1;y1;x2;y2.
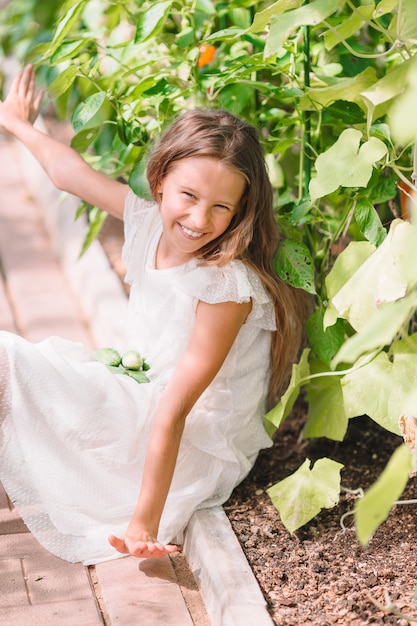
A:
0;65;43;124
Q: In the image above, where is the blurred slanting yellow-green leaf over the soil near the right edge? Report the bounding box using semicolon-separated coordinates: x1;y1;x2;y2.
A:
355;444;413;546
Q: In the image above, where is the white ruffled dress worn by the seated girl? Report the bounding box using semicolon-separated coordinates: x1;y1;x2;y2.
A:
0;192;275;565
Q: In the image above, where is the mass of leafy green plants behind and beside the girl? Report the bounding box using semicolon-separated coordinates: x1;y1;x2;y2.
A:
0;0;417;543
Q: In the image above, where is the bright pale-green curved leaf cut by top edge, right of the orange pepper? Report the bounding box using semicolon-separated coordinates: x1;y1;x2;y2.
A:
265;0;344;58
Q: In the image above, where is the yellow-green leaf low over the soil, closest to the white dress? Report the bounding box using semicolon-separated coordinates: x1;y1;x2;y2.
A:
267;458;343;533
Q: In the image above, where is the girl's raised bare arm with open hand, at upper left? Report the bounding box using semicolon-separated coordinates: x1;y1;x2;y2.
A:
0;65;128;219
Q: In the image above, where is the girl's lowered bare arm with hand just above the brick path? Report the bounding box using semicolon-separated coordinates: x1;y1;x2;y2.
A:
109;302;251;558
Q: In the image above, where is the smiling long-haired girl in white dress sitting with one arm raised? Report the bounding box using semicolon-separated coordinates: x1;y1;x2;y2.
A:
0;66;306;564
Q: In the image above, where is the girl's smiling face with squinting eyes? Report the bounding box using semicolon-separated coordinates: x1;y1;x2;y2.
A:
156;157;246;269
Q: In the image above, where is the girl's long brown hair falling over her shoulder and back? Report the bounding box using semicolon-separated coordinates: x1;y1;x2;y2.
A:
147;109;308;406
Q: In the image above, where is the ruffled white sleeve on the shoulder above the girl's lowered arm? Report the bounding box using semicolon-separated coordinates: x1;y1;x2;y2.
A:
173;261;276;331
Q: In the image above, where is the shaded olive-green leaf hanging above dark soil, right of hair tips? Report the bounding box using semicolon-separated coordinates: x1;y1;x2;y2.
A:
303;368;348;441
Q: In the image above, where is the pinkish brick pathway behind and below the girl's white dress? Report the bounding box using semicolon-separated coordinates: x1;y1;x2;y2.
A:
0;135;209;626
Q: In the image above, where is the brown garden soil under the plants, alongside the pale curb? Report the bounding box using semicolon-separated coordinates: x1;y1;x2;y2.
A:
100;211;417;626
